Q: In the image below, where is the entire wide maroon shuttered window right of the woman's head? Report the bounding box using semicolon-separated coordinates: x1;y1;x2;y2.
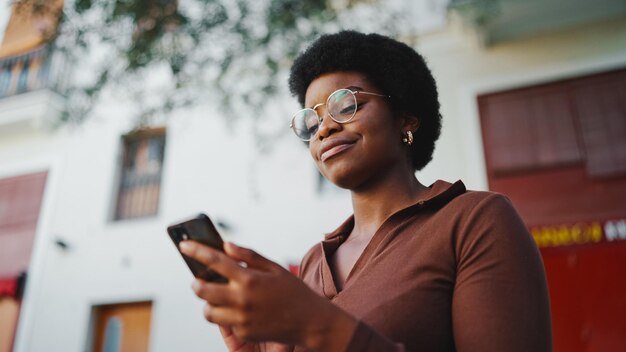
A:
479;70;626;178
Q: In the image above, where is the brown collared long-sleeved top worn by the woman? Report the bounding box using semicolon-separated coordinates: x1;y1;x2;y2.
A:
295;181;552;352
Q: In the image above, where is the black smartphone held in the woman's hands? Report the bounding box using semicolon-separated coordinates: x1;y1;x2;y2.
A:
167;214;228;283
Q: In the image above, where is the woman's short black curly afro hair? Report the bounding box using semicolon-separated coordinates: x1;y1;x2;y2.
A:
289;31;441;170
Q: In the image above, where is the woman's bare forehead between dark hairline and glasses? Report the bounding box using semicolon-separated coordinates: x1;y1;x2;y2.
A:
304;71;376;106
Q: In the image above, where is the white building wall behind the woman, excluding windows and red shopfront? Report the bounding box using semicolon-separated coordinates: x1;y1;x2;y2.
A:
0;1;626;352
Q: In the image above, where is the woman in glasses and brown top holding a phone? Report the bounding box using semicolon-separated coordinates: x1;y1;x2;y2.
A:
182;32;551;352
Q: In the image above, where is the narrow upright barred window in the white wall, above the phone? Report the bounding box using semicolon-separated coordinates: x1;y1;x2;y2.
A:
114;128;165;220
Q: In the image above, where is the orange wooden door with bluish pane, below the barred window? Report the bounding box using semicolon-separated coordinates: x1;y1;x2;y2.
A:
92;302;152;352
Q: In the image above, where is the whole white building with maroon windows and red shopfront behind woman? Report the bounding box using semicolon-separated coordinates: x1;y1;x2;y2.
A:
0;0;626;352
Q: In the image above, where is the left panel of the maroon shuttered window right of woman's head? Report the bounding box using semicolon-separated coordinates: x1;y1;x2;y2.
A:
481;87;582;176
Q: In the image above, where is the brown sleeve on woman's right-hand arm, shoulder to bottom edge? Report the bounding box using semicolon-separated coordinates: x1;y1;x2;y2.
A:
452;194;552;352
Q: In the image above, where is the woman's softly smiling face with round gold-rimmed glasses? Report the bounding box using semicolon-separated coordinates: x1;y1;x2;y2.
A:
305;72;409;190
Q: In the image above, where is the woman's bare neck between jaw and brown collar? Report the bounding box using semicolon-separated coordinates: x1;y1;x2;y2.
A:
351;164;428;237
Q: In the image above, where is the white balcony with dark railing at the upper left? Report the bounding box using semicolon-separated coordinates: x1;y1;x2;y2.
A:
0;45;63;134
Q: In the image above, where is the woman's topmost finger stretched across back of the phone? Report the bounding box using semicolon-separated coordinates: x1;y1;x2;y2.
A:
179;241;244;279
